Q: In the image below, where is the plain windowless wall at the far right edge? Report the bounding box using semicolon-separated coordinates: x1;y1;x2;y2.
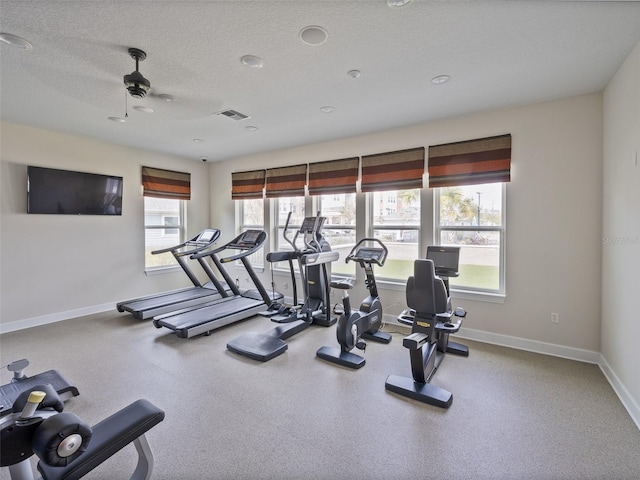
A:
602;43;640;418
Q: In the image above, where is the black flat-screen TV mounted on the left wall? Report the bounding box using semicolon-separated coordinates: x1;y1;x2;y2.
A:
27;166;122;215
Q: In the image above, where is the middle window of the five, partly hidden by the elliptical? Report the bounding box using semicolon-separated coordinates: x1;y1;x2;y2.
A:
314;193;356;275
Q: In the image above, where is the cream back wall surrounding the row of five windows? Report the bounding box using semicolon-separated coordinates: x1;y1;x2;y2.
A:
211;93;602;352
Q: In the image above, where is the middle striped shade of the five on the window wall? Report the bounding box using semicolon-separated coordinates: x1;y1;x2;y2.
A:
309;157;360;195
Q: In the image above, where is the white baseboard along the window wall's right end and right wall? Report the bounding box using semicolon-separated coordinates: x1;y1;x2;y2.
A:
384;315;640;429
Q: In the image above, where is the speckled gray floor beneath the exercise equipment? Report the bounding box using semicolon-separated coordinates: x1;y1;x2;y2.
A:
0;311;640;480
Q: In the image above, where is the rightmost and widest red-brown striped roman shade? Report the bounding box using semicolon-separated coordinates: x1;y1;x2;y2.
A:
429;134;511;188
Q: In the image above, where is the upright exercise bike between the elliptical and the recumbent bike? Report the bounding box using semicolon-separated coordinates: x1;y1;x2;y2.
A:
316;238;391;369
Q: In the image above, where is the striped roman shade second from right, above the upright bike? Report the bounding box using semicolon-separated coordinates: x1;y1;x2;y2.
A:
361;147;424;192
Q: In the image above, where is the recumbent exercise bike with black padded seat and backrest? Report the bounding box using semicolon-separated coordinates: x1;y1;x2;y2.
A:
385;259;468;408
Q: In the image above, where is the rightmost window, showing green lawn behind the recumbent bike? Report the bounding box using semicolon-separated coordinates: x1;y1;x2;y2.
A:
434;183;506;294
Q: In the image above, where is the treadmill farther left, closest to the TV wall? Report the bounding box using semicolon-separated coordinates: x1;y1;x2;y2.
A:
116;228;227;320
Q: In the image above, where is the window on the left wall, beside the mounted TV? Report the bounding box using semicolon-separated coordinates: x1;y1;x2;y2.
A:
144;197;185;270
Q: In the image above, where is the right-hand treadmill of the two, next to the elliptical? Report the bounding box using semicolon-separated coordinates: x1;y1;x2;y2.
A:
153;230;283;338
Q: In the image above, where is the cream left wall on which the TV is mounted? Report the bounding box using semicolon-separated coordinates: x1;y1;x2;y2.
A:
0;123;210;331
